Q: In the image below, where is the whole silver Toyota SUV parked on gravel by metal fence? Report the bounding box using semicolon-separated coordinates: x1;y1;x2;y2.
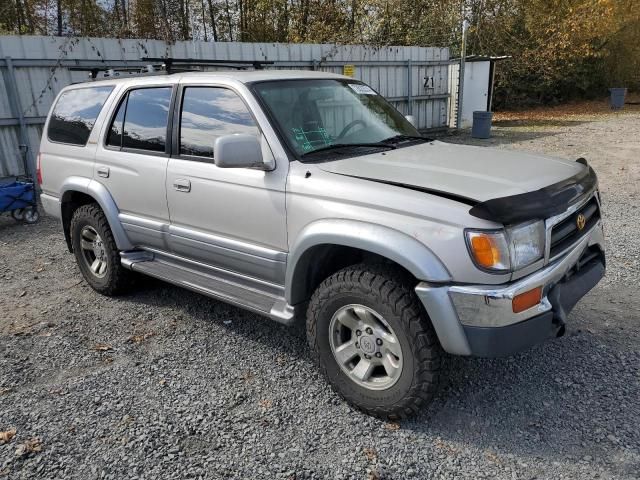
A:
38;71;605;419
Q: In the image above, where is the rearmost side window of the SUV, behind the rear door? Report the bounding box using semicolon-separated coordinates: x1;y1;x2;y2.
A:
47;87;113;145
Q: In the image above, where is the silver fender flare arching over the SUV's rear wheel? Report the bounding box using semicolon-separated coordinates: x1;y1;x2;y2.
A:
60;177;133;250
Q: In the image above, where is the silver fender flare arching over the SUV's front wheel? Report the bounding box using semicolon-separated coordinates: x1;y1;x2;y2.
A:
285;218;451;305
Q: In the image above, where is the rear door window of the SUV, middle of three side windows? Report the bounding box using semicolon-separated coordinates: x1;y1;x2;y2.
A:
107;87;172;152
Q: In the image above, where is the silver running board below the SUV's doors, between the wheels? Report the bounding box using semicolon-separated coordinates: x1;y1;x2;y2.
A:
120;251;295;325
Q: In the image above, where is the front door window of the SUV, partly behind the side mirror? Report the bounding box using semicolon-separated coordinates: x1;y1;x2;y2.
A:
180;87;260;158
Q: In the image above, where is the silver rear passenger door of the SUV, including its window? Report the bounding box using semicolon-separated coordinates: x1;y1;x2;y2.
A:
94;84;175;250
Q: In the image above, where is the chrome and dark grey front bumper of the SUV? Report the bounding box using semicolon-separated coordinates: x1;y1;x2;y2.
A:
416;221;604;357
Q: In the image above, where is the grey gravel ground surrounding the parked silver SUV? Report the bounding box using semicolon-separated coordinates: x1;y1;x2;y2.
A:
0;106;640;480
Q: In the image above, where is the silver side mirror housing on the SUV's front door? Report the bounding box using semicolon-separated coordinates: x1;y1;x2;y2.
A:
213;133;264;168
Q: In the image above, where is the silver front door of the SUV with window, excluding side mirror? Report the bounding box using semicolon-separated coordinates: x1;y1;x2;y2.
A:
166;85;288;285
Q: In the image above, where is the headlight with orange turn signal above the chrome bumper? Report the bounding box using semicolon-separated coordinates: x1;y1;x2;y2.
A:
465;220;545;273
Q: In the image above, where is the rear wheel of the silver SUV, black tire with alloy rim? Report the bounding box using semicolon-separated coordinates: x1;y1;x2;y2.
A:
70;203;133;296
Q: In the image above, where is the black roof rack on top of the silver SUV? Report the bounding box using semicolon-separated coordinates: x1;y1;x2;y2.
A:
69;57;274;80
